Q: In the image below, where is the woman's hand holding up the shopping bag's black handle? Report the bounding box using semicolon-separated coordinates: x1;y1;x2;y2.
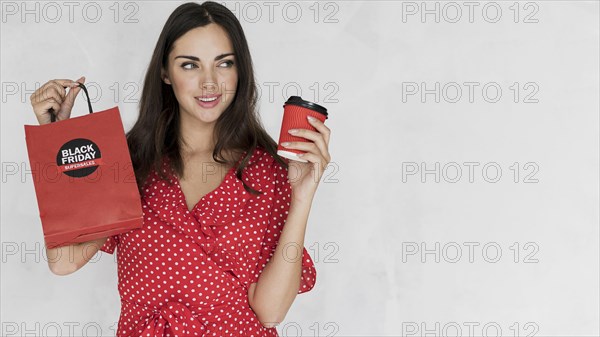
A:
30;76;85;125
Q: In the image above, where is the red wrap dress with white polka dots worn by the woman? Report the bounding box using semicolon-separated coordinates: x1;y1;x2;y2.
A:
100;147;316;337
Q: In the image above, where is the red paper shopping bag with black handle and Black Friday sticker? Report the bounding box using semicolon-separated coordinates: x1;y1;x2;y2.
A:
25;83;143;248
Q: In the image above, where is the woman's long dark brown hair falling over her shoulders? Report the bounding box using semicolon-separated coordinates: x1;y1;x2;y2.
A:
126;1;287;194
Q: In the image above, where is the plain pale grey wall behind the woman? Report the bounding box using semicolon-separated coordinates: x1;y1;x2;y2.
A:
1;1;600;336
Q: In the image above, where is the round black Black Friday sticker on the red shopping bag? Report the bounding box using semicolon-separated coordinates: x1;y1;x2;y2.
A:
56;138;102;178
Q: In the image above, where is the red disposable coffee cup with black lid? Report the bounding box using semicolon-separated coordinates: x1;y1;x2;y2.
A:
277;96;328;163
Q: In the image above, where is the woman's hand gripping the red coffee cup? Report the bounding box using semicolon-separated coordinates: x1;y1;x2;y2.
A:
281;117;331;202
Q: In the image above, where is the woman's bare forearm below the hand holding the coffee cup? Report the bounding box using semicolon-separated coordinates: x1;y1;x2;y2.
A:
250;199;311;326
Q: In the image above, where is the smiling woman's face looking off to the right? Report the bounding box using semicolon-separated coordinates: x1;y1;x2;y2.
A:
162;23;238;124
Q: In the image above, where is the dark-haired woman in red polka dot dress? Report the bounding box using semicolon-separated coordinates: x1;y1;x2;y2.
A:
31;1;330;336
